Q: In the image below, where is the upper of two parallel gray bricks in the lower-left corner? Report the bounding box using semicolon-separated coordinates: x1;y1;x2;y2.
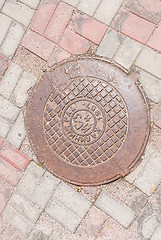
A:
9;193;42;223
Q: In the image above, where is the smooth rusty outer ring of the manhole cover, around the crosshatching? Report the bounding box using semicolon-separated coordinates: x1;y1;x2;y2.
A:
25;56;150;186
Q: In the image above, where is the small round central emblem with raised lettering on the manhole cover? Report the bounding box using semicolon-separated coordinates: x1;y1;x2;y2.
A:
62;99;105;144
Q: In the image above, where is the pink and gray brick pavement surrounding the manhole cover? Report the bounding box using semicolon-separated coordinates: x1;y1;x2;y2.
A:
0;0;161;240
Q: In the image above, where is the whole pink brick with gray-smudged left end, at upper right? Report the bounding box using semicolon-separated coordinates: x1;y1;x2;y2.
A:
112;12;155;44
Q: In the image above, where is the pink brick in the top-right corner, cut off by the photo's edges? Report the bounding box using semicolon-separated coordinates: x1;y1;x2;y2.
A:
125;0;161;23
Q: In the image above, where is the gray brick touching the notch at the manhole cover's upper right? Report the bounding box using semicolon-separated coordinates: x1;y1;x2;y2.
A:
115;38;142;70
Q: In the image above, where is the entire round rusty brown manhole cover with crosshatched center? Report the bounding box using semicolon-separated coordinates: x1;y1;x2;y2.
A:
26;58;149;185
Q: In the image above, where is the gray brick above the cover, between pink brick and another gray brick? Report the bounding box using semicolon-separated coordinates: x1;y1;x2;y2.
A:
96;29;124;58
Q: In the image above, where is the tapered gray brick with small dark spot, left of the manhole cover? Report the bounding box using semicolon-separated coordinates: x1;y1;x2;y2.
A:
7;112;26;149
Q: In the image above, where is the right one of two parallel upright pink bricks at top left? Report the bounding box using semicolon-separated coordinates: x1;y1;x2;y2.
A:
44;2;73;43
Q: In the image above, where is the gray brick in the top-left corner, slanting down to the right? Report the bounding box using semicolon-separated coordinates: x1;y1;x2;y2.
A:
2;0;34;27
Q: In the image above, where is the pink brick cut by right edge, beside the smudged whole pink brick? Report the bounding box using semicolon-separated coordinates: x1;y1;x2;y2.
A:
147;22;161;52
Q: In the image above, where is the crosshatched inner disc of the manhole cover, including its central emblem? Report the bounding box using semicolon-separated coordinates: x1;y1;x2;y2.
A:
43;77;128;167
